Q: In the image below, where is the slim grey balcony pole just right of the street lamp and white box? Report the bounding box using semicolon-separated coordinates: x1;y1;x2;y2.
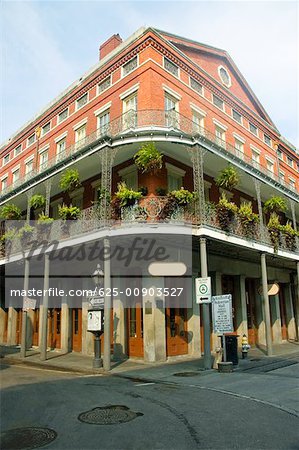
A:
103;237;111;371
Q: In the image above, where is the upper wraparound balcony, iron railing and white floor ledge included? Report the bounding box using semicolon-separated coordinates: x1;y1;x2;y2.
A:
1;110;299;201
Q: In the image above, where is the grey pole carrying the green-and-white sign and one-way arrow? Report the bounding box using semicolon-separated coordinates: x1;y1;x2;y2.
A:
200;238;212;369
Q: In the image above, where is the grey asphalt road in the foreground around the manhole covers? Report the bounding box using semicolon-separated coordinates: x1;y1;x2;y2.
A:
1;365;299;450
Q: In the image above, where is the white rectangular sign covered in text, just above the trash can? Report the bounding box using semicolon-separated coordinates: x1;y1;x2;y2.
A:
212;294;234;334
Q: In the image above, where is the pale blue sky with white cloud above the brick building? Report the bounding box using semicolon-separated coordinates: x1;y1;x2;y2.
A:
0;0;299;146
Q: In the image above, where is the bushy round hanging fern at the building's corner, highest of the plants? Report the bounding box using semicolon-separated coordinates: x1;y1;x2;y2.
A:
134;142;163;173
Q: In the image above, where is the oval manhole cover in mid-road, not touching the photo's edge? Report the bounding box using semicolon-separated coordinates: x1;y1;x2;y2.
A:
78;405;143;425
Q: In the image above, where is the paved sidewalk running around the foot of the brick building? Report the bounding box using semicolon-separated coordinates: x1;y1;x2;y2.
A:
1;342;299;380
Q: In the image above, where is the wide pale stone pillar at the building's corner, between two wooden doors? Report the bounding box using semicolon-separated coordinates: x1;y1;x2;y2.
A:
142;277;166;362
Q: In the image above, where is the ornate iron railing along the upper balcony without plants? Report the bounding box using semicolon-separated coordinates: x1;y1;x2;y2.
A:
1;110;299;198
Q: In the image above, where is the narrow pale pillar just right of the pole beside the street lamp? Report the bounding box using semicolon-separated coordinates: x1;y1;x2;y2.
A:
113;277;127;361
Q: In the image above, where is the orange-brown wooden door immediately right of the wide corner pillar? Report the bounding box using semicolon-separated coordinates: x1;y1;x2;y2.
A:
166;308;188;356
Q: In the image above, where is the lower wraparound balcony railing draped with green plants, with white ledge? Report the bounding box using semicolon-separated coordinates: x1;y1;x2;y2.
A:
0;196;299;258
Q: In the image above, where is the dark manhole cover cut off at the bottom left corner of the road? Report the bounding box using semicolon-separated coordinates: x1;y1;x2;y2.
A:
1;428;57;450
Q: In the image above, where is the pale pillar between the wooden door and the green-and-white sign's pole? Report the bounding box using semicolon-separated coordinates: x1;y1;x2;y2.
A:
188;278;201;358
